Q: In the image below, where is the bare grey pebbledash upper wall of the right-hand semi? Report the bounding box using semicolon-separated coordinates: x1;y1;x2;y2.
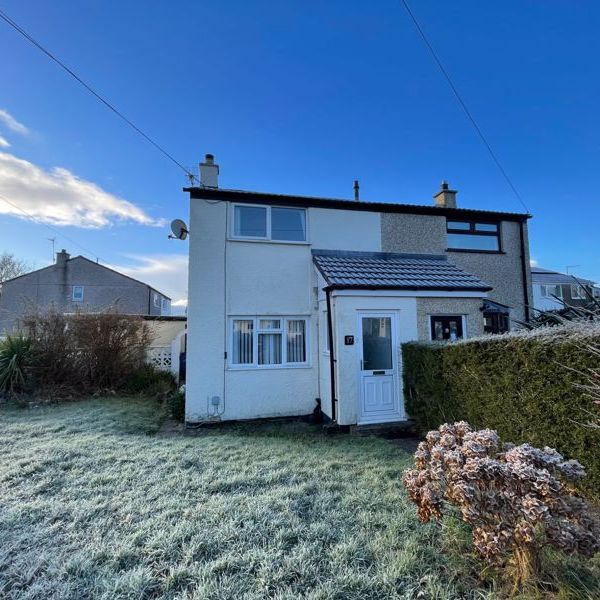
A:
381;213;533;322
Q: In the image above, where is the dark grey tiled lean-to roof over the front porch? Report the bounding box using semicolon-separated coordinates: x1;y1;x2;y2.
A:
312;250;492;292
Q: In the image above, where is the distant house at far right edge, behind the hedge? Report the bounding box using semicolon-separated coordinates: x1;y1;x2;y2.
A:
531;267;600;311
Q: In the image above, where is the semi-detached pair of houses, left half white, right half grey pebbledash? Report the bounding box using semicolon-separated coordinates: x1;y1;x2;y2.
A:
185;155;531;425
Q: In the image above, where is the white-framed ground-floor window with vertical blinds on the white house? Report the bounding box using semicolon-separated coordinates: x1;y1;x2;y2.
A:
231;317;308;368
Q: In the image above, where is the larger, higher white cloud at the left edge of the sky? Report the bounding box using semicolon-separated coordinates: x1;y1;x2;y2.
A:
0;152;164;229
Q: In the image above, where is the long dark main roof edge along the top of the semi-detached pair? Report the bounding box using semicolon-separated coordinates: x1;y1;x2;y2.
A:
183;187;531;221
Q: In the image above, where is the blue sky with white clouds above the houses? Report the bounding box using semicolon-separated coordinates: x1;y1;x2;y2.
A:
0;0;600;308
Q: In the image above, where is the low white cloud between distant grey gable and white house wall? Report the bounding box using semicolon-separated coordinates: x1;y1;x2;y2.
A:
114;252;188;314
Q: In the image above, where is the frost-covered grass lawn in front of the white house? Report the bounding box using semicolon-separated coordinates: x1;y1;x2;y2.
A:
0;398;480;600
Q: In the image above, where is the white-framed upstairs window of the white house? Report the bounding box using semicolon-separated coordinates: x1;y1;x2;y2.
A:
233;205;306;242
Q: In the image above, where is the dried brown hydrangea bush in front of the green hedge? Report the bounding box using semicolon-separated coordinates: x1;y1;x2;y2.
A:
403;421;600;585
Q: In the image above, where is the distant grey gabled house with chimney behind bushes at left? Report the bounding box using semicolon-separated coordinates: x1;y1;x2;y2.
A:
0;250;171;334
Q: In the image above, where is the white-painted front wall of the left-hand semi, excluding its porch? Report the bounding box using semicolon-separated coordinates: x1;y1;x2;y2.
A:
186;198;381;422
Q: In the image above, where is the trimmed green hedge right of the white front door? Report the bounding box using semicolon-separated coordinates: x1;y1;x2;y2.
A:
402;325;600;495
